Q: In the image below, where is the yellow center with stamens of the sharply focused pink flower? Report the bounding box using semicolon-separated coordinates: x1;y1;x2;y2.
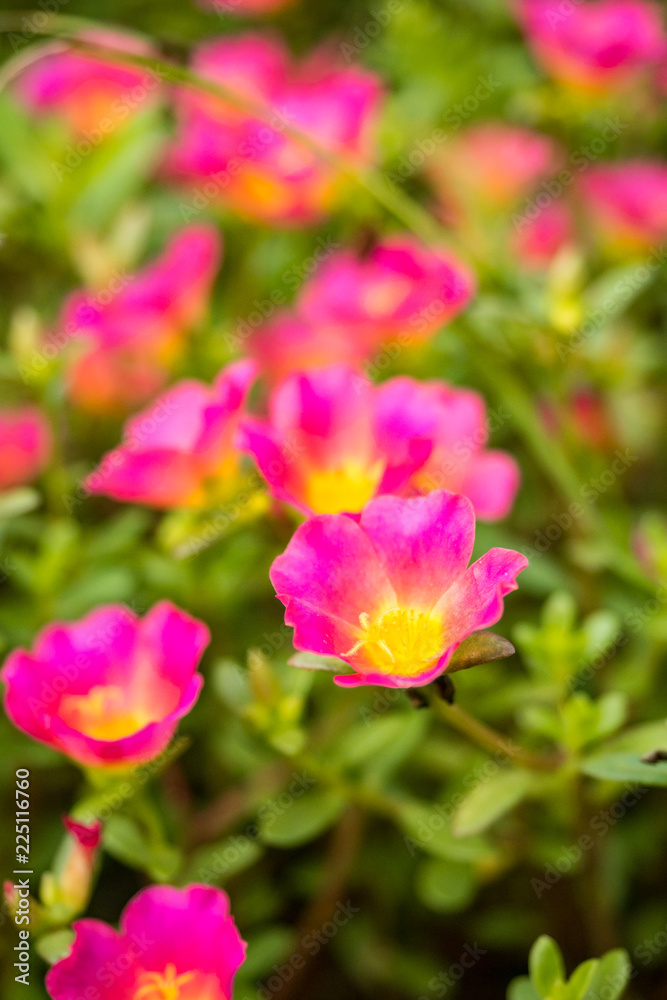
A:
343;608;444;677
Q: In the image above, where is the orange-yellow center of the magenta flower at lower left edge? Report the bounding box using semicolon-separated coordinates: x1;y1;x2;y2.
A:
60;684;153;740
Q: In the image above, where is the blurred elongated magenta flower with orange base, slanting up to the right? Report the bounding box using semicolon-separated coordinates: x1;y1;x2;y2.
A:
59;225;221;415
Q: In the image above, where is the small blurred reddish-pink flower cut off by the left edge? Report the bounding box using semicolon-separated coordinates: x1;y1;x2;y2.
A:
0;406;52;490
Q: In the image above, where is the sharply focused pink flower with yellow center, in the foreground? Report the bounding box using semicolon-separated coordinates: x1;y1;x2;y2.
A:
270;490;528;688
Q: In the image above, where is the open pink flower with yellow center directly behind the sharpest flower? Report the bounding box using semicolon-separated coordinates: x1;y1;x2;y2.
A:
242;366;431;514
